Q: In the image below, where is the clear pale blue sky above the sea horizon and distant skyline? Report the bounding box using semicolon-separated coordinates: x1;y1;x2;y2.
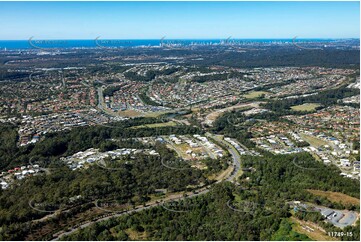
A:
0;2;360;40
